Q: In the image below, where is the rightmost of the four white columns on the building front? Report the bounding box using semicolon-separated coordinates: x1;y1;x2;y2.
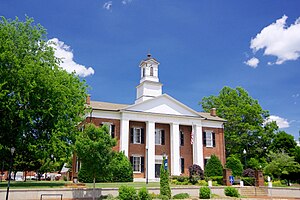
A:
192;124;204;169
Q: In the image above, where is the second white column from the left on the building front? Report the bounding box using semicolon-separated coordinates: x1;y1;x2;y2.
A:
146;122;155;180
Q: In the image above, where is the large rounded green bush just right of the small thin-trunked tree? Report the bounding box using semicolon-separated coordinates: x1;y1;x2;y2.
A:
109;152;133;182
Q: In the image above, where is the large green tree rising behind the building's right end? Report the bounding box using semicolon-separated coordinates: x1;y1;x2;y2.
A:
201;87;278;161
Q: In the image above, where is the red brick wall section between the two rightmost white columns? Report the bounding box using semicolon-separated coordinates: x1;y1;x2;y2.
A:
179;125;193;176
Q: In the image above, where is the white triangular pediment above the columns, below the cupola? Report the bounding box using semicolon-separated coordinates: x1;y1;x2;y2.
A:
124;94;200;117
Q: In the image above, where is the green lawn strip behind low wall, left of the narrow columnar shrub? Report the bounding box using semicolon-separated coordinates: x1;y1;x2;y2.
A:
0;181;159;189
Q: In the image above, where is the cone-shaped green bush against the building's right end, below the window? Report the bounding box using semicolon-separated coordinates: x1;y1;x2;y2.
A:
204;155;223;177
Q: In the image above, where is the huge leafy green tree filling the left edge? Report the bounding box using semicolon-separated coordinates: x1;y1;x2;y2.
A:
0;17;87;173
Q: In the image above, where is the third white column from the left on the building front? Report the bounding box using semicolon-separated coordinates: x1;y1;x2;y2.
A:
170;123;181;176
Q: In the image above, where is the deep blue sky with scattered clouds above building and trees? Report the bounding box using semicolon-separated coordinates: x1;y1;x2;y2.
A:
0;0;300;139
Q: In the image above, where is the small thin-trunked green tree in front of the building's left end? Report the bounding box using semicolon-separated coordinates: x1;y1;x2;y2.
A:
75;124;116;199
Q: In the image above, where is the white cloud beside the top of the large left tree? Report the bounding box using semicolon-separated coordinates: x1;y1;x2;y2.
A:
48;38;95;77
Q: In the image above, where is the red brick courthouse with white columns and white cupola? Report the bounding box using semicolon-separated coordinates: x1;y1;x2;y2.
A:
73;54;225;181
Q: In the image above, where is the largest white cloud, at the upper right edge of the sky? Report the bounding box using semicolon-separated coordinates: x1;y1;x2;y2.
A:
250;15;300;65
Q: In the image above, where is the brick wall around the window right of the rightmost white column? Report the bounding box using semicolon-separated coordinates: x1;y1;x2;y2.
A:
202;127;226;166
